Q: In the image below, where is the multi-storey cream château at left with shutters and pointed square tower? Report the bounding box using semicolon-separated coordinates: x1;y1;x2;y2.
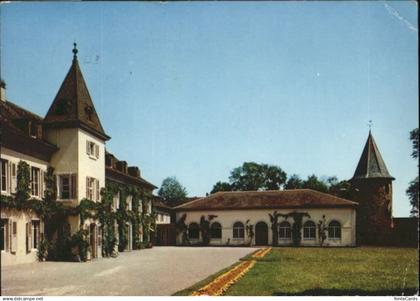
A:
0;44;156;265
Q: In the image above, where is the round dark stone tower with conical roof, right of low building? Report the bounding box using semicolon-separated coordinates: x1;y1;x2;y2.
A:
350;130;394;244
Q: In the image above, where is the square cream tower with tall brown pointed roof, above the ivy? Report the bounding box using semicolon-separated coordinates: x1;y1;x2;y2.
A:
43;43;110;233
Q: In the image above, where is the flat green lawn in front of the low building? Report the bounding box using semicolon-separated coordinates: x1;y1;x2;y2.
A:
226;247;419;296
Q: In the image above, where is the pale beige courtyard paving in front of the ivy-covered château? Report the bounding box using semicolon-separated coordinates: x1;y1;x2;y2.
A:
1;247;255;296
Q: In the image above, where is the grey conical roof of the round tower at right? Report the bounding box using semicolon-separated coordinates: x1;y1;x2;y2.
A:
352;131;394;180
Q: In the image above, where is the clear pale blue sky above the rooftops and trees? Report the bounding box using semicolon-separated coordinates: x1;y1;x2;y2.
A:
0;1;418;216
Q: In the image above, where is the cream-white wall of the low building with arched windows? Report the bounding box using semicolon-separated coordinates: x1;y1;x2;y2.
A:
176;208;356;247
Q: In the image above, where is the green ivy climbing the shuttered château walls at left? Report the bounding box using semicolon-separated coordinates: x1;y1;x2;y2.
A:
0;161;155;261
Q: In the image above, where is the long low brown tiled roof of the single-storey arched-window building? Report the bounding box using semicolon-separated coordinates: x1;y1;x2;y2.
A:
175;189;357;211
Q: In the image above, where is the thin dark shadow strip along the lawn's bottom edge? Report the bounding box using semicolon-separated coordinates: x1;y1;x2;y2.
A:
273;288;419;296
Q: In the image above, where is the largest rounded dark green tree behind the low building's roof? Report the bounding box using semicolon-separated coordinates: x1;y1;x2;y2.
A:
229;162;287;191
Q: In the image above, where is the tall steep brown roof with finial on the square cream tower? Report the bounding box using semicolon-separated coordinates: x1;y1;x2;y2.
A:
44;43;110;140
